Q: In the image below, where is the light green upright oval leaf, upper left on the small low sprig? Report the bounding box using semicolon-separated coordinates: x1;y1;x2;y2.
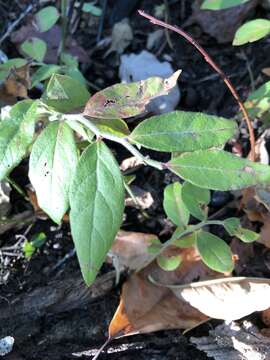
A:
163;182;189;226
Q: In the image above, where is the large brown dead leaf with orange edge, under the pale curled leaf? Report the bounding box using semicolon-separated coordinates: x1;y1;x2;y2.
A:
109;247;220;336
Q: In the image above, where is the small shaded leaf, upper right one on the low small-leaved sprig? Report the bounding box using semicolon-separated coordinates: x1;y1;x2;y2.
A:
182;181;211;221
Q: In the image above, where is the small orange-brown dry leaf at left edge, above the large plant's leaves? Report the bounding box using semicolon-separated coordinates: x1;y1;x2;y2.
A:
0;64;31;105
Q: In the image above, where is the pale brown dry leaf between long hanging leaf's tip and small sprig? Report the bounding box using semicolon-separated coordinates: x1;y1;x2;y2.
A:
109;230;158;270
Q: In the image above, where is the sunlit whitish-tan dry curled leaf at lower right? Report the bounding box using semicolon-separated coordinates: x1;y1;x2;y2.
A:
171;277;270;320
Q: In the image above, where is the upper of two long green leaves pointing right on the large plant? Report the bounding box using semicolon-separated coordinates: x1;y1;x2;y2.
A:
130;111;237;152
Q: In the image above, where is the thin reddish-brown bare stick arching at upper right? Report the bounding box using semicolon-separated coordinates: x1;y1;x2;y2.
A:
138;10;255;161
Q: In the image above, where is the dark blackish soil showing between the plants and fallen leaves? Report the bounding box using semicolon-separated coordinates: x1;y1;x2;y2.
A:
0;0;270;360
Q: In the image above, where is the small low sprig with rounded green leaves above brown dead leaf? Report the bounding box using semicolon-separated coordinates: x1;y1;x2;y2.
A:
157;181;259;273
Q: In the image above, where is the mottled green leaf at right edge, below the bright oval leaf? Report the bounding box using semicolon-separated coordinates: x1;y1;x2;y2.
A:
245;81;270;118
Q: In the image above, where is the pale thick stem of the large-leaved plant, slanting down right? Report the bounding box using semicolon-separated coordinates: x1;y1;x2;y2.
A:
64;114;166;170
